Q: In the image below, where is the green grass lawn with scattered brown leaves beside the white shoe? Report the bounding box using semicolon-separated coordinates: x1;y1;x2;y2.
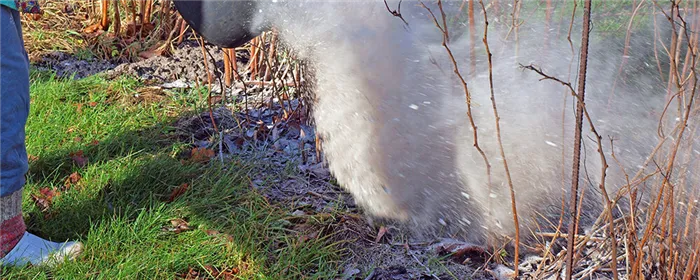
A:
0;72;338;279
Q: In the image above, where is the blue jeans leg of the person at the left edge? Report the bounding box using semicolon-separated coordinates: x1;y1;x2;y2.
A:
0;5;29;197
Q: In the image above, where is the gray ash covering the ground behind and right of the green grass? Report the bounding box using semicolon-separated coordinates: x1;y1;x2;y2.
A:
30;37;504;280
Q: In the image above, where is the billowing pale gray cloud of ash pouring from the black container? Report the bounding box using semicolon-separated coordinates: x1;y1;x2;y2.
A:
246;1;700;242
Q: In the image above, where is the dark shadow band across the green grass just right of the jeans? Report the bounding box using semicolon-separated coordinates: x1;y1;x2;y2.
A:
25;120;194;240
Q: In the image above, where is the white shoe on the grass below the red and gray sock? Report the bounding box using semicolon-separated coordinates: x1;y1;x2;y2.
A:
0;232;83;266
